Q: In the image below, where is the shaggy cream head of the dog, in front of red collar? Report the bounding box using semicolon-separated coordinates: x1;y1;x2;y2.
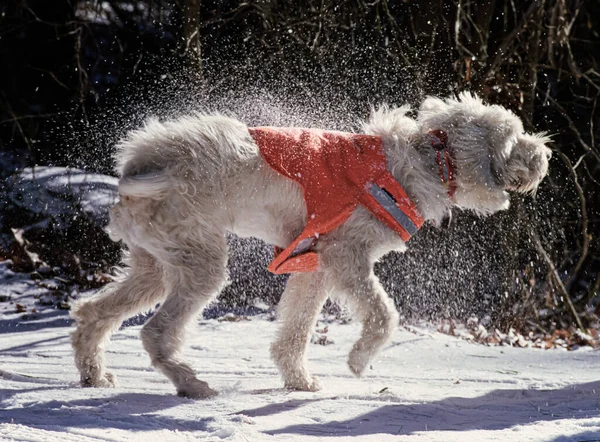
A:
418;93;551;215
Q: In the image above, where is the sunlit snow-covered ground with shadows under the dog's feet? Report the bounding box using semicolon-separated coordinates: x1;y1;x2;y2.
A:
0;310;600;442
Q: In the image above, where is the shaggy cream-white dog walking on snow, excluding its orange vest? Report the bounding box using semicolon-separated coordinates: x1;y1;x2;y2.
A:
72;94;550;398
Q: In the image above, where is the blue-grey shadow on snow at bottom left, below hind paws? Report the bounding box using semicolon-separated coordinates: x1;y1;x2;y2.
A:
0;393;214;432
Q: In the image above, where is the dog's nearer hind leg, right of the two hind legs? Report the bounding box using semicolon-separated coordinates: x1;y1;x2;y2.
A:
141;232;227;398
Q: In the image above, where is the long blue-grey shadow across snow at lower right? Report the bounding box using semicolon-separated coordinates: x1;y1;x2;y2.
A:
255;382;600;442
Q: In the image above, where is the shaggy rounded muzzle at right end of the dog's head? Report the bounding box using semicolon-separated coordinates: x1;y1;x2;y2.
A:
502;134;552;192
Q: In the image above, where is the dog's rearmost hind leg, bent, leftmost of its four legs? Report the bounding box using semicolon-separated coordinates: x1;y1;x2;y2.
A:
71;247;164;387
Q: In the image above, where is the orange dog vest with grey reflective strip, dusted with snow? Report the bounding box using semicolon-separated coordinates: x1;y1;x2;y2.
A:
249;127;423;274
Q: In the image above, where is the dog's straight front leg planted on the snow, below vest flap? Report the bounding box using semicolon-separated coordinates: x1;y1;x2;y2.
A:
271;272;327;391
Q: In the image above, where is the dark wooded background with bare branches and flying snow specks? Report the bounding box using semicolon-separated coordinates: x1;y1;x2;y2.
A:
0;0;600;330
